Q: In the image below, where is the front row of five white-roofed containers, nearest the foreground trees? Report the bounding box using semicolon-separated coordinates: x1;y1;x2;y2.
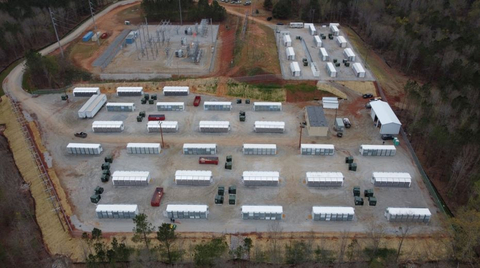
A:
95;204;432;223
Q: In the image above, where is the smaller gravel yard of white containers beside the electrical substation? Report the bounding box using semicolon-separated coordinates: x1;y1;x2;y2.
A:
275;22;375;81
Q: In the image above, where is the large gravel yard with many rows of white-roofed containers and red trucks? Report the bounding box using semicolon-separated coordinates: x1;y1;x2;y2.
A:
29;86;439;232
